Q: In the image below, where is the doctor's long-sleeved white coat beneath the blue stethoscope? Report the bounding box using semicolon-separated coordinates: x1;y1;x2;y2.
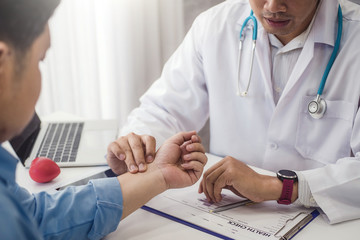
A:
121;0;360;223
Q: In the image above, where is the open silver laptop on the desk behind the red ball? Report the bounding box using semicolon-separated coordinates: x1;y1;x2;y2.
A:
10;115;118;167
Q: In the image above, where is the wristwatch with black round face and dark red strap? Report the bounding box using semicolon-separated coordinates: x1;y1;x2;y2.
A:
276;170;298;205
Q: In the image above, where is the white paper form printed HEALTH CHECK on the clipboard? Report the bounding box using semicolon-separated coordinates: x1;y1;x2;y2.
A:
146;155;314;240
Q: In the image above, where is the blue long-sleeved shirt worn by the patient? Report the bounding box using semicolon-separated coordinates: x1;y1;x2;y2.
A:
0;146;123;240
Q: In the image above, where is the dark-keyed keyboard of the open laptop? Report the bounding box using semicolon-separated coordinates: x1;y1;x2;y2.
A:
37;122;84;162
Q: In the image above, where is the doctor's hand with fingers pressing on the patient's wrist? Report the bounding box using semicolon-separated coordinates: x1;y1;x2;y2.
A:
107;133;156;175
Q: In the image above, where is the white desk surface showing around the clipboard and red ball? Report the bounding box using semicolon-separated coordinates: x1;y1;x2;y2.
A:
10;136;360;240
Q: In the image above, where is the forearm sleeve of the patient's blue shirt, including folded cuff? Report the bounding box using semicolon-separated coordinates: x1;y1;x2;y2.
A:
14;178;123;240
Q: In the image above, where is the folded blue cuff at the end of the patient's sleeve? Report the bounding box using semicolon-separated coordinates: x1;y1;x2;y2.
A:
88;178;123;239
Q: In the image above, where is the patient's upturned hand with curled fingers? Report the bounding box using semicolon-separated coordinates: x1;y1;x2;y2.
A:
153;131;207;189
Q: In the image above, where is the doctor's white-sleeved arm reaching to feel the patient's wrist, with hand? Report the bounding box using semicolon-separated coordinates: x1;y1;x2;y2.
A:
107;14;209;174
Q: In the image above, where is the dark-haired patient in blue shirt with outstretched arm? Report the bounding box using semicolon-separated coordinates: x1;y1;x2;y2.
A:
0;0;207;239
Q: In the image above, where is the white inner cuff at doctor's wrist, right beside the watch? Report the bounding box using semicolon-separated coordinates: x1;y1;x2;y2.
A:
294;172;319;207
